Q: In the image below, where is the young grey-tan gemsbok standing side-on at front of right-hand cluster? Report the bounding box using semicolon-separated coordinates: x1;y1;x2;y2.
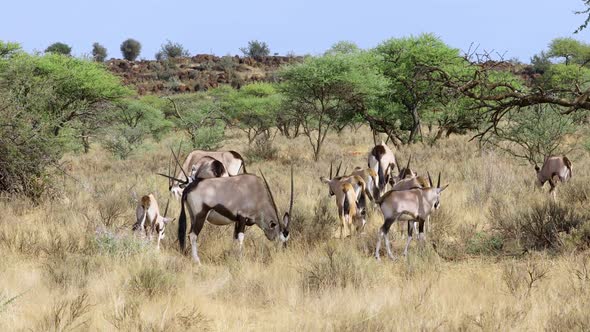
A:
375;173;448;260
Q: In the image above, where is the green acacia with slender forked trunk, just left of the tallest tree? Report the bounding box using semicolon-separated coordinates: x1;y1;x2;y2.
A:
279;53;385;161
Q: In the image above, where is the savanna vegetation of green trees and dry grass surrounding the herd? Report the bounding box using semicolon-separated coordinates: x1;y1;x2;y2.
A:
0;27;590;331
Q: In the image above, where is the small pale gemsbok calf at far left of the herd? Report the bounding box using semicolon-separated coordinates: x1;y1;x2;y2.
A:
132;194;175;250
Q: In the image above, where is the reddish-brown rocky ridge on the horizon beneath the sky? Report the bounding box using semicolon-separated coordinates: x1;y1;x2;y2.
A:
106;54;303;95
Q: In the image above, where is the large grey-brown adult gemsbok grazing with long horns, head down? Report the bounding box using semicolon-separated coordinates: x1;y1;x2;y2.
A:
171;161;293;264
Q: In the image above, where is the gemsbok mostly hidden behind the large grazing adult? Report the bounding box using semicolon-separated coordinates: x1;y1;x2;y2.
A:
169;149;246;199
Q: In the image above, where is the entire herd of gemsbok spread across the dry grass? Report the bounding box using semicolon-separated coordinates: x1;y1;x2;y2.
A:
133;142;572;264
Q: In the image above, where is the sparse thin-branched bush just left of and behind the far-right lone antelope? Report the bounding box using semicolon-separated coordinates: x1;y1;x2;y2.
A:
485;105;577;165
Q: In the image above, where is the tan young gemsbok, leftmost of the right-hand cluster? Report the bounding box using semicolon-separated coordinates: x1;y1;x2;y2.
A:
320;163;367;239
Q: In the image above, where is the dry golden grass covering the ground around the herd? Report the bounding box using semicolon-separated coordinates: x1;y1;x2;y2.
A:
0;130;590;331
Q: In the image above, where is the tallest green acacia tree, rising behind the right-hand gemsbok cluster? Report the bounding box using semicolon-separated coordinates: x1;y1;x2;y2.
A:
368;34;462;143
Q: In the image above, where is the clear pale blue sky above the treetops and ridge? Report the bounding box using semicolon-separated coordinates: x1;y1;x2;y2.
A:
0;0;590;62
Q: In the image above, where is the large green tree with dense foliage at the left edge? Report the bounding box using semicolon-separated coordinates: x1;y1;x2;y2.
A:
0;53;130;199
